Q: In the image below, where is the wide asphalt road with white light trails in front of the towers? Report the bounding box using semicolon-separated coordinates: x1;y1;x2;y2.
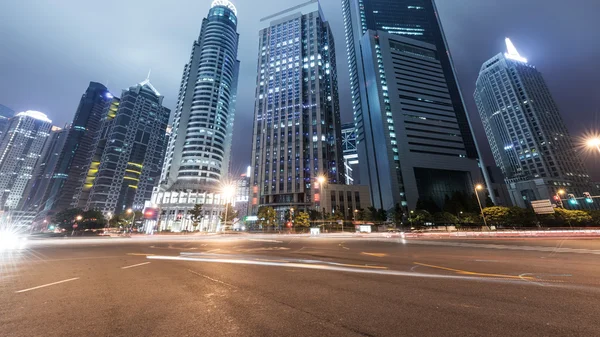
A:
0;236;600;337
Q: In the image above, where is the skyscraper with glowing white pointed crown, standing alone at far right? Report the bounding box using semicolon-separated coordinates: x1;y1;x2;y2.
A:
474;38;595;207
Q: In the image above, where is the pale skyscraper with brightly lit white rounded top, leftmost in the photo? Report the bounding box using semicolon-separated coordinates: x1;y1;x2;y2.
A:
0;110;52;210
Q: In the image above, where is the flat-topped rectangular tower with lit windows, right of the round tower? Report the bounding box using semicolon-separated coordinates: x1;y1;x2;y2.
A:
250;0;344;214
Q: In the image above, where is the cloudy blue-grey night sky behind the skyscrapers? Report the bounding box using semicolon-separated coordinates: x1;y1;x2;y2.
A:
0;0;600;180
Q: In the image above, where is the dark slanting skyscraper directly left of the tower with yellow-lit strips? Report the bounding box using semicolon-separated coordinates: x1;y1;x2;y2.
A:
40;82;113;212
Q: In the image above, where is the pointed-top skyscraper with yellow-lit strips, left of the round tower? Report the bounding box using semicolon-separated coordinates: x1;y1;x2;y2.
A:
84;79;171;215
